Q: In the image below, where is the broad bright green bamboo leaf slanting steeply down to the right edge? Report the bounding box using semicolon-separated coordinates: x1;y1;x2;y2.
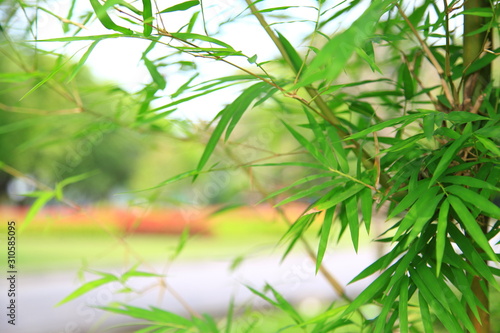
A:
448;195;498;261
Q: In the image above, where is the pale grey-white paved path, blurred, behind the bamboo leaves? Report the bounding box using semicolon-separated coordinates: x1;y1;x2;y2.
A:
0;249;375;333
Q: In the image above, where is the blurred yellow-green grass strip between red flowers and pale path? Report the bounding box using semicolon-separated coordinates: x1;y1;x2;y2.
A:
0;202;378;271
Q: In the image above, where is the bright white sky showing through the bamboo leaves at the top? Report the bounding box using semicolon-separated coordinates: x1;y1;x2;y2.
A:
32;0;364;120
